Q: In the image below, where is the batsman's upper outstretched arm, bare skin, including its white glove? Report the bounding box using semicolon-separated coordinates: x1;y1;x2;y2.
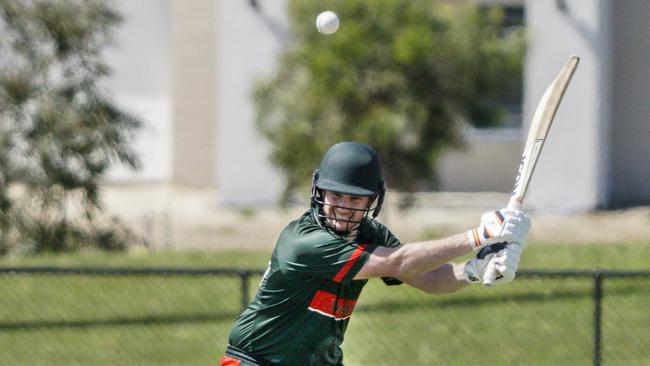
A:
354;210;530;279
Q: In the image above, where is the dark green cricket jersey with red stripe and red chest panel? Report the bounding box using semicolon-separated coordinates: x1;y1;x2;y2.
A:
229;211;399;366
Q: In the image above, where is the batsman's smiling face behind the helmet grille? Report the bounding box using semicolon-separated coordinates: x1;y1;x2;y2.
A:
323;191;370;232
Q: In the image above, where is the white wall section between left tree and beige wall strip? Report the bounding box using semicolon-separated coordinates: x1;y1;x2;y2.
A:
105;0;172;182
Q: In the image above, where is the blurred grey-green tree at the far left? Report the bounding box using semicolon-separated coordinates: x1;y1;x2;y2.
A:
0;0;140;254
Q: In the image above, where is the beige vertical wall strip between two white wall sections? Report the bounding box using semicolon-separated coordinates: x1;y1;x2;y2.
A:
170;0;219;187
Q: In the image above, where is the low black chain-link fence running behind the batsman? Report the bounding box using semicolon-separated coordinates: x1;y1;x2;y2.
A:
0;267;650;365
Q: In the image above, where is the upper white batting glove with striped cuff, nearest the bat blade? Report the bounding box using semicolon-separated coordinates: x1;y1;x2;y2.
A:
467;208;530;251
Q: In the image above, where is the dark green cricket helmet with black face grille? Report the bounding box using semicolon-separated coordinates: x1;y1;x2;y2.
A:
311;142;386;231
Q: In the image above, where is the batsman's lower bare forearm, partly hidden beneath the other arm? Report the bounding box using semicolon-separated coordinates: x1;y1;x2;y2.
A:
400;263;468;294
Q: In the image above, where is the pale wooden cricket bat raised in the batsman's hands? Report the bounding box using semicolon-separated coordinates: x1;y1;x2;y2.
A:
483;55;580;286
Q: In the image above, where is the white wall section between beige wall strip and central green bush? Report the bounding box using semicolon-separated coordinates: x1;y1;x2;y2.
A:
214;0;288;205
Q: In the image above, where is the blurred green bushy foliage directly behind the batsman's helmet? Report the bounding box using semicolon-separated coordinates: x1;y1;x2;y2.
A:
255;0;525;198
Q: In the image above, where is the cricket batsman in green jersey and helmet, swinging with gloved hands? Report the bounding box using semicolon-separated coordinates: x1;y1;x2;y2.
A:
220;142;530;366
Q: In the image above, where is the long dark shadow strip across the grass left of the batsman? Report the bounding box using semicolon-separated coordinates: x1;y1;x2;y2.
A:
0;313;237;332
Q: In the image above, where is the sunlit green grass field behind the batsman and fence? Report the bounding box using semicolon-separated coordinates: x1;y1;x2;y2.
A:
0;243;650;365
